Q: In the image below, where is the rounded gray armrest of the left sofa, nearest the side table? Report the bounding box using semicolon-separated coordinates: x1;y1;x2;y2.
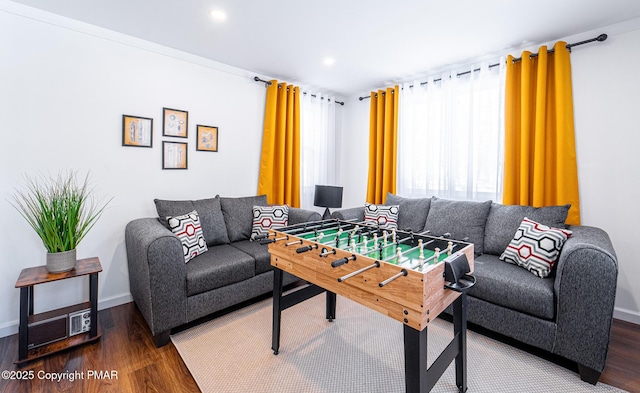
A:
125;218;188;336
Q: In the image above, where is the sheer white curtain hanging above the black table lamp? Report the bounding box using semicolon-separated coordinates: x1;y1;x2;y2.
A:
300;93;336;211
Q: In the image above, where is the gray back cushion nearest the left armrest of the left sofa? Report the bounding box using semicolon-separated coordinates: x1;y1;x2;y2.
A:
153;196;229;247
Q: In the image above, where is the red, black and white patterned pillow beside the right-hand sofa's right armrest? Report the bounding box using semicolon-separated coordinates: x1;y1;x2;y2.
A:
500;217;572;277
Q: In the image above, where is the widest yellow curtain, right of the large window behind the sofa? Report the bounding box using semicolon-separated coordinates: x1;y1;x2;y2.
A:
503;41;580;225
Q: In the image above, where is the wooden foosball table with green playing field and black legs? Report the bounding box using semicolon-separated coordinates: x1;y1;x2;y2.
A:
261;219;475;393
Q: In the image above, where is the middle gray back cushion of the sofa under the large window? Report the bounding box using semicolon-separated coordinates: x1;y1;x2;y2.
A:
424;197;492;254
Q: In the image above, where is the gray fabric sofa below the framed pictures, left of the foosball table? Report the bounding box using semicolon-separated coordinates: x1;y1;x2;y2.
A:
125;195;321;346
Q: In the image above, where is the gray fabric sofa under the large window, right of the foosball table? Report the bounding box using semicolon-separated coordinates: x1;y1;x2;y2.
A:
332;194;618;384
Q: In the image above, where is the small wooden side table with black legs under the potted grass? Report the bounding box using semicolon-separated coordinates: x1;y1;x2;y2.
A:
15;258;102;365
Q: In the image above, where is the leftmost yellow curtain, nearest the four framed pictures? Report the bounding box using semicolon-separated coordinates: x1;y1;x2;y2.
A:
258;80;300;207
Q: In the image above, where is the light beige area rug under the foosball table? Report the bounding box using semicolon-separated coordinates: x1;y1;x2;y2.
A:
171;295;621;393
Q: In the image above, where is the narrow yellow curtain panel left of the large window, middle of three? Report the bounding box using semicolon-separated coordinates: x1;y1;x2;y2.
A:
367;85;400;204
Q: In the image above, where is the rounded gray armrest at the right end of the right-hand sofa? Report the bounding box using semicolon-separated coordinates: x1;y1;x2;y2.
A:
554;226;618;372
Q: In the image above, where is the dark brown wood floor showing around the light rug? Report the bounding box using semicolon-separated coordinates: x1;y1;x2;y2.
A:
0;303;640;393
